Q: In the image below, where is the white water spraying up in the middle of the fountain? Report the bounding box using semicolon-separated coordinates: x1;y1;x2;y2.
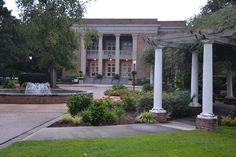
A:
25;82;52;95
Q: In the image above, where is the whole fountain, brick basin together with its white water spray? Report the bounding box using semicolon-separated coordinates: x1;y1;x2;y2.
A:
0;83;93;104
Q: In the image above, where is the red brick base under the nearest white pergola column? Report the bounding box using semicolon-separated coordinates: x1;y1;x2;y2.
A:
196;115;218;131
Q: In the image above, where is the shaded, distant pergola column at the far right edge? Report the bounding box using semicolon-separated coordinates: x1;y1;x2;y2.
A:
225;64;234;99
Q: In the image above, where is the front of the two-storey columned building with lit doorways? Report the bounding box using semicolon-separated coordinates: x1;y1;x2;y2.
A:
69;19;185;81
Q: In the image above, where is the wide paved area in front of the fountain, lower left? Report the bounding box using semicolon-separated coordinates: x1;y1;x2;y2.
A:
0;104;67;148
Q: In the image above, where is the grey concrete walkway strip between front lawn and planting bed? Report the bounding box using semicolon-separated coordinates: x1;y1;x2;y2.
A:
24;122;195;140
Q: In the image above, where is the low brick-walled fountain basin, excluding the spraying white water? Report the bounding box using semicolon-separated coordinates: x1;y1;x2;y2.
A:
0;89;93;104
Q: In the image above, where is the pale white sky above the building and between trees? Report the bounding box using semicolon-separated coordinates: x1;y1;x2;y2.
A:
5;0;207;21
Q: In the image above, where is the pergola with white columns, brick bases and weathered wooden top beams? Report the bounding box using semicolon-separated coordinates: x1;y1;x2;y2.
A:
144;27;236;130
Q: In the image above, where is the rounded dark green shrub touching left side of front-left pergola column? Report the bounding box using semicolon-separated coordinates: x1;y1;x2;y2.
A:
136;95;153;113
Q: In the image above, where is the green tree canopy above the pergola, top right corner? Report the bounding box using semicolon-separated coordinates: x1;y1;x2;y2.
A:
188;0;236;30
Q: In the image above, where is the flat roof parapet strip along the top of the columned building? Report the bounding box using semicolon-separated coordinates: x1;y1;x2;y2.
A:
82;19;185;27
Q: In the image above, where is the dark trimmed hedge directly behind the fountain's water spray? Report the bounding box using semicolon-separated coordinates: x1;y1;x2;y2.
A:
18;73;49;84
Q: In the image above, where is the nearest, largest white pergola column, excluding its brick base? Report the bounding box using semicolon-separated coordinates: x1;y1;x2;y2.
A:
201;40;214;117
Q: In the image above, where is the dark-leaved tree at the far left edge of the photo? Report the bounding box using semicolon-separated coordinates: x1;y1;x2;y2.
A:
0;0;25;76
